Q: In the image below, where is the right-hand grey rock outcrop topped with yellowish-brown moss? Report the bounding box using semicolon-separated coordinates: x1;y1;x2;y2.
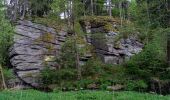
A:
80;17;144;64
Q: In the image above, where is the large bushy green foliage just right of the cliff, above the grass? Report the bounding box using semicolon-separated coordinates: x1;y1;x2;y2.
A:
125;29;167;89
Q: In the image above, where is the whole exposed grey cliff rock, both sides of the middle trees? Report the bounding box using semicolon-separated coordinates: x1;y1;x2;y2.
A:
9;19;143;88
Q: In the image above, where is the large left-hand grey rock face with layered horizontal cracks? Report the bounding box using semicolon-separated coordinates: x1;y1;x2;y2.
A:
10;21;66;88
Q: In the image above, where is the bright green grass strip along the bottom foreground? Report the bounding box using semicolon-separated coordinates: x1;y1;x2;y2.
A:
0;90;170;100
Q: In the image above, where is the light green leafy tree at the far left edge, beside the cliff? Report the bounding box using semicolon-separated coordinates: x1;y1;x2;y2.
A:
0;0;13;89
